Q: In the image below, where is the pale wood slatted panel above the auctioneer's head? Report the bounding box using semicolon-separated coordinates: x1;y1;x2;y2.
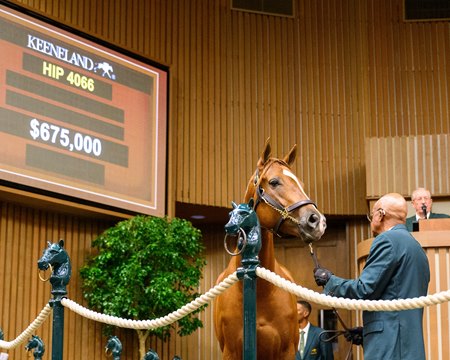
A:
366;134;450;198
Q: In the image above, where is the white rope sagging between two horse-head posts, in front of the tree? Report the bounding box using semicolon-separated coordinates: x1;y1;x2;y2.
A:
61;272;239;330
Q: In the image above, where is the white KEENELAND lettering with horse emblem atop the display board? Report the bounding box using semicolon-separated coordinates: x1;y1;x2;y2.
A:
27;34;116;80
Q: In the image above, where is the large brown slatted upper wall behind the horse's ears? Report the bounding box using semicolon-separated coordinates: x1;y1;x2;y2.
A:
9;0;450;214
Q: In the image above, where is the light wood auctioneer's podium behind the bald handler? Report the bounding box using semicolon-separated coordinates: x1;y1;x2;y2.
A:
357;218;450;360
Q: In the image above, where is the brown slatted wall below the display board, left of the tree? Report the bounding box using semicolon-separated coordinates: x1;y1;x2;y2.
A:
0;201;117;360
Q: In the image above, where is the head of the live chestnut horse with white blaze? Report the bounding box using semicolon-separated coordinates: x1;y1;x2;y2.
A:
245;140;326;243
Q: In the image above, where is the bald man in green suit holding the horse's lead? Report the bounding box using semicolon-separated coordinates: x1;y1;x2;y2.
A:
314;193;430;360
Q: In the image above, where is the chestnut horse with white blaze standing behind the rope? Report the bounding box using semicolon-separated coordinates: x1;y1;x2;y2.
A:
214;140;326;360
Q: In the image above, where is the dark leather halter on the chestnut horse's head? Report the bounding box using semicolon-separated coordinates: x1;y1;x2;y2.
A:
253;160;317;237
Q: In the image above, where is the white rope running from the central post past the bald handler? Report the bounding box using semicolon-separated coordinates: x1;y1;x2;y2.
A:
256;267;450;311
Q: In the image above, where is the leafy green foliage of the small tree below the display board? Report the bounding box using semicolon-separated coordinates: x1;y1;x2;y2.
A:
80;215;206;339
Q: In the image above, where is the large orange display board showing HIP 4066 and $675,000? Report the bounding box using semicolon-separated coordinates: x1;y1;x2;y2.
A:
0;4;168;216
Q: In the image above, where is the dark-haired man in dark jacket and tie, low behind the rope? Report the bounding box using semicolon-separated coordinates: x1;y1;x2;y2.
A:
295;300;334;360
